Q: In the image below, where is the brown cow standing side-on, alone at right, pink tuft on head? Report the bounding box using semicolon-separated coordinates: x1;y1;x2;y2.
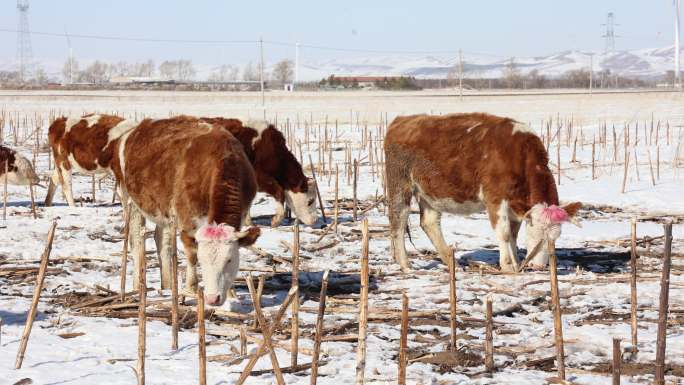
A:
385;113;581;271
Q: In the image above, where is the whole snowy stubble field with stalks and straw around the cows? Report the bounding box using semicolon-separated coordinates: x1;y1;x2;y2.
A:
0;91;684;384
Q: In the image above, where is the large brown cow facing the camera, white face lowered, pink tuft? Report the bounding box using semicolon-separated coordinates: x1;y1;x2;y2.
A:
117;116;259;306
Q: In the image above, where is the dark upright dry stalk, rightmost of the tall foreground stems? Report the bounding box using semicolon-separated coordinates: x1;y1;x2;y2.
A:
653;223;672;385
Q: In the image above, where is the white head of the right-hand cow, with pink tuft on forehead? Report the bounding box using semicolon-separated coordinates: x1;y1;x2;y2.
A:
525;202;582;269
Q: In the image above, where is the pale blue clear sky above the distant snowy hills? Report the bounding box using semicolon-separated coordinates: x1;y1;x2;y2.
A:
0;0;674;74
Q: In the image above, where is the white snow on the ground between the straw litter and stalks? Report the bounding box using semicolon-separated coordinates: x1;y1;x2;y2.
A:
0;93;684;384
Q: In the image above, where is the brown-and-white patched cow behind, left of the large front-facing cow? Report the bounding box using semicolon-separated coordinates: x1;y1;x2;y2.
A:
45;114;138;207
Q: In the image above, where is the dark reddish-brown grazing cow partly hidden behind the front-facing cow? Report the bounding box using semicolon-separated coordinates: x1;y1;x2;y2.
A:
201;118;317;227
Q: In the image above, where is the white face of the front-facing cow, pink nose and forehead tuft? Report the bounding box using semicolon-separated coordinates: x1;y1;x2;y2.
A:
195;223;259;306
